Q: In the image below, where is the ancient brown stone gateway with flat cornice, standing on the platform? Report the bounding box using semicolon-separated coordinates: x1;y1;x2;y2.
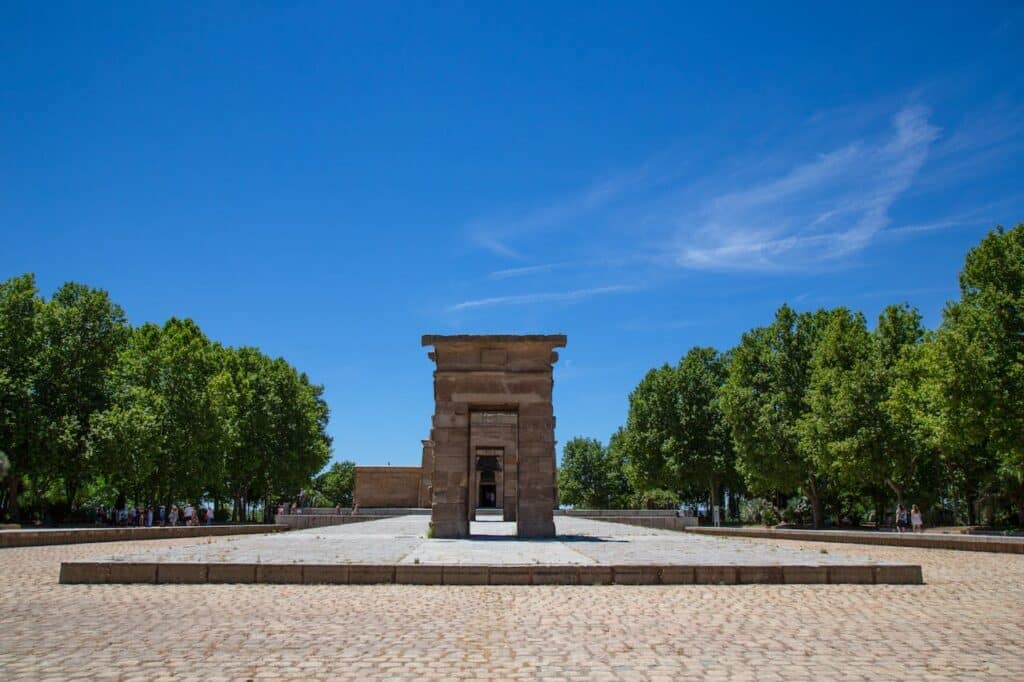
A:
421;335;565;538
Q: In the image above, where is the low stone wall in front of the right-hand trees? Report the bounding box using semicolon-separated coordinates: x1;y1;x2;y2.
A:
687;527;1024;554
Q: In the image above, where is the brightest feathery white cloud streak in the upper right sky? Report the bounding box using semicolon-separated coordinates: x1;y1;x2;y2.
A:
672;106;939;271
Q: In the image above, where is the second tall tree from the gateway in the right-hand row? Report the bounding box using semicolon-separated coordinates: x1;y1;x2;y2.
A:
721;305;829;526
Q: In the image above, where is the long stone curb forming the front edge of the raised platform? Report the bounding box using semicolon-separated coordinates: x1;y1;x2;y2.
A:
60;561;924;585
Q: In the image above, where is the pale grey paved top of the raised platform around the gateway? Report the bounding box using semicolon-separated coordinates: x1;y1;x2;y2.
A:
86;516;905;565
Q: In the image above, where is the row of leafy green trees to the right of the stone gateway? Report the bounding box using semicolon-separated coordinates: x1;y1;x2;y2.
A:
559;224;1024;525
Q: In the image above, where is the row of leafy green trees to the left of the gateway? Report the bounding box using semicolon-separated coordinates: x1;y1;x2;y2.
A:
0;274;331;519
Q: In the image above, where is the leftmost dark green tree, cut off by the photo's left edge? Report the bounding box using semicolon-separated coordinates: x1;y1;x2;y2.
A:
0;274;43;520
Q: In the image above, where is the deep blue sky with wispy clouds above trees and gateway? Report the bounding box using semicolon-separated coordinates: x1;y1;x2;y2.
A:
0;2;1024;464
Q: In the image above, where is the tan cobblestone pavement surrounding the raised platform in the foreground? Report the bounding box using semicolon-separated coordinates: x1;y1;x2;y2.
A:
0;539;1024;680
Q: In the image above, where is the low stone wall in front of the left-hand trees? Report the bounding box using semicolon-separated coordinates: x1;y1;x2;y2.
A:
0;523;289;548
